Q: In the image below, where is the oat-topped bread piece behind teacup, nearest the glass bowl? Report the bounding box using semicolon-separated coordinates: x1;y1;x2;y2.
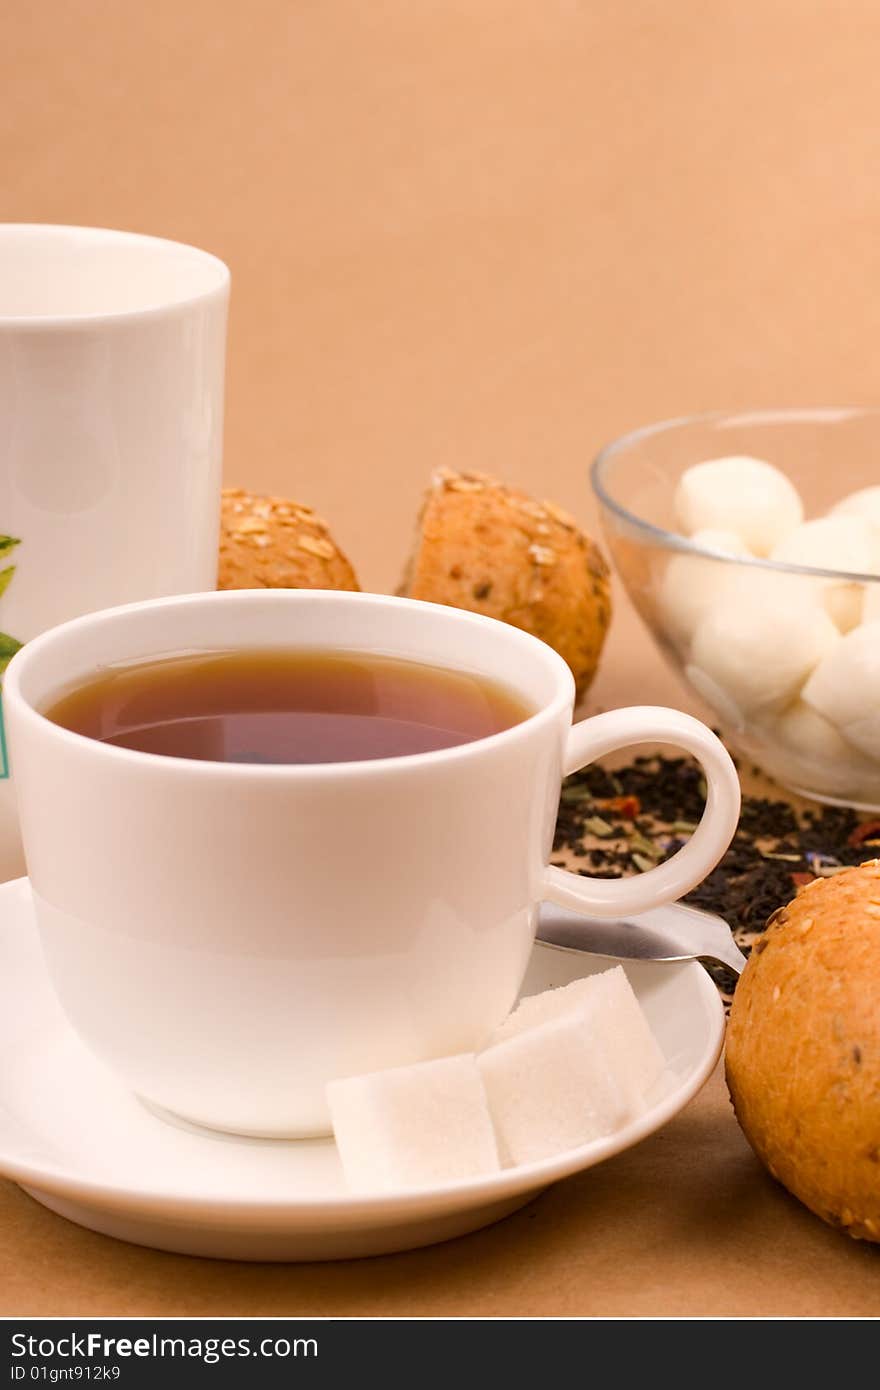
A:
399;468;612;696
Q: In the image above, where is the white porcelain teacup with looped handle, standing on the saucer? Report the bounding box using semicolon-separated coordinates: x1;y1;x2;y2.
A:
4;591;740;1136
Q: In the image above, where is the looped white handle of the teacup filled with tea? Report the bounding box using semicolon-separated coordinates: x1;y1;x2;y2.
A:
544;705;741;917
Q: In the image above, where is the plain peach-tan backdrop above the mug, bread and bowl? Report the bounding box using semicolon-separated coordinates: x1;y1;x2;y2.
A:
0;0;880;587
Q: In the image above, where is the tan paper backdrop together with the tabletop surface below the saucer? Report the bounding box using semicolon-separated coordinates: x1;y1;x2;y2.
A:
0;0;880;1315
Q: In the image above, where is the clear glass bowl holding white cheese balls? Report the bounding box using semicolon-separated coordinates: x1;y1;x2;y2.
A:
592;407;880;810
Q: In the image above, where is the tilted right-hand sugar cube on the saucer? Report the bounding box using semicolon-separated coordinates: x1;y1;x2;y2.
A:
477;966;666;1163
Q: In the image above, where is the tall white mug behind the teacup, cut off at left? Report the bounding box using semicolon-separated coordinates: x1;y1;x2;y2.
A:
0;224;229;878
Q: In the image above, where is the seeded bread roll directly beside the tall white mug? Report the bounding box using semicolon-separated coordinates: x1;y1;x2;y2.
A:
217;488;360;589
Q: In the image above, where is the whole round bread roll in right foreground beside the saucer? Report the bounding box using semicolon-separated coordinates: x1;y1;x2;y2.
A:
727;859;880;1241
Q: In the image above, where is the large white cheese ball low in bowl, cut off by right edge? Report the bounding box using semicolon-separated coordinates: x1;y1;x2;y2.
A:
804;621;880;758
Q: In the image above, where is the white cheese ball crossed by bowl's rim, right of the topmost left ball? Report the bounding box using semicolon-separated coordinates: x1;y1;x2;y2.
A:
770;516;880;632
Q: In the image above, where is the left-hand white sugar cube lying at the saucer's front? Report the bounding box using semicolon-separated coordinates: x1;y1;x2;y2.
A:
327;1054;500;1193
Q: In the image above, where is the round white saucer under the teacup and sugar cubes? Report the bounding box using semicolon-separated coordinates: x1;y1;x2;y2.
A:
0;878;724;1259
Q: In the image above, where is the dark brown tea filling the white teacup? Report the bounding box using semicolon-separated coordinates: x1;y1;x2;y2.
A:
44;651;531;763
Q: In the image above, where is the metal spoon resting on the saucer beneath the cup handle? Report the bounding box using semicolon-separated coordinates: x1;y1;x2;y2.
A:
537;902;745;974
